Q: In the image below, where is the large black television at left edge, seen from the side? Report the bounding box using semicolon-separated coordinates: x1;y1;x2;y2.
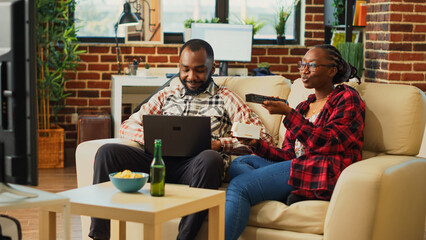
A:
0;0;38;197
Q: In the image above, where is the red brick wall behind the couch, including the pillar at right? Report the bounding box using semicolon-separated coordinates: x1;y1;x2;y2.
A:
59;0;426;158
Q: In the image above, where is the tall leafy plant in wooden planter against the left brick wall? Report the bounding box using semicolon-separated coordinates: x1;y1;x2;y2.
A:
36;0;84;168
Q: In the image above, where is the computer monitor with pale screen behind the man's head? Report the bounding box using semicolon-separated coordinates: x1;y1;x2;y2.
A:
191;23;253;76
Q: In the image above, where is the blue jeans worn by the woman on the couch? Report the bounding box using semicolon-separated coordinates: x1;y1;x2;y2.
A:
225;155;294;240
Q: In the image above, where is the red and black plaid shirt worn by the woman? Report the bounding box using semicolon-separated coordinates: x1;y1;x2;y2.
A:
256;84;365;200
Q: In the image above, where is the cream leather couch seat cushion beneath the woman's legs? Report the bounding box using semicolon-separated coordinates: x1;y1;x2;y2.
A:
248;200;329;234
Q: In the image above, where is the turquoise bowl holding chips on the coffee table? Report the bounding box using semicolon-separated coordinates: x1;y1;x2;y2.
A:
109;172;149;193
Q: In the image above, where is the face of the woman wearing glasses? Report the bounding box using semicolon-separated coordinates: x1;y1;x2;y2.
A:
300;48;337;89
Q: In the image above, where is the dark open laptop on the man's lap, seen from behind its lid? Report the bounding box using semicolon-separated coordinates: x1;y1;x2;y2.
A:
143;115;211;157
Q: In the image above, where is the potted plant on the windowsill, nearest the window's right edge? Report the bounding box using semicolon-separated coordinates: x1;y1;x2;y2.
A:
274;0;299;45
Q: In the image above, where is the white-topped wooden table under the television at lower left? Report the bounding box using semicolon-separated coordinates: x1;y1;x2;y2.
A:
0;184;71;240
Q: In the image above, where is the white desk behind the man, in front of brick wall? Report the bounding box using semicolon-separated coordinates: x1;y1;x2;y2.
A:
111;75;168;137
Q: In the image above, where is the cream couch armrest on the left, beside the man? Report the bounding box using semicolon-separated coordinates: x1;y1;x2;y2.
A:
75;138;141;188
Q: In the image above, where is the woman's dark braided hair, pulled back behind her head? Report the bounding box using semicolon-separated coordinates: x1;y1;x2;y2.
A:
314;44;361;84
